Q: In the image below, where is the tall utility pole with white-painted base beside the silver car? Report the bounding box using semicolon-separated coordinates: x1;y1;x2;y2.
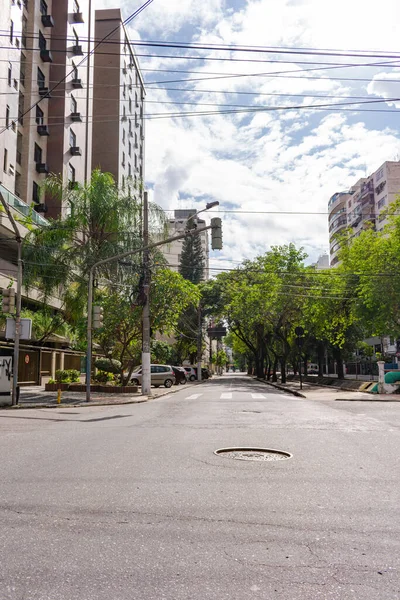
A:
142;192;151;396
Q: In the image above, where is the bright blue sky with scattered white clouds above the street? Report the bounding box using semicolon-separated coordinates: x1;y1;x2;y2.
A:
96;0;400;269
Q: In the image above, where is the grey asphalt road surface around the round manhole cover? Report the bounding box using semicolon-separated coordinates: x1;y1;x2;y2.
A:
0;375;400;600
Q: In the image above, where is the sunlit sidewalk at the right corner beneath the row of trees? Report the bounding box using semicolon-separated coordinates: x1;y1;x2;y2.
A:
257;379;400;402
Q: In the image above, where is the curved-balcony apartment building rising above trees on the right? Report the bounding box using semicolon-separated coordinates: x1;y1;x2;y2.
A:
328;161;400;266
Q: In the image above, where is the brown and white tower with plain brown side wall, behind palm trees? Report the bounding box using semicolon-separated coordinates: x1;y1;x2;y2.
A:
92;9;145;190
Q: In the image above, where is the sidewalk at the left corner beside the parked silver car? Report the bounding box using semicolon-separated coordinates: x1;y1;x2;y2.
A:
0;381;202;410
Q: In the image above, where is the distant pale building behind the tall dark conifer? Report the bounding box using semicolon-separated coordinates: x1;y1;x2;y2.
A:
160;209;210;279
